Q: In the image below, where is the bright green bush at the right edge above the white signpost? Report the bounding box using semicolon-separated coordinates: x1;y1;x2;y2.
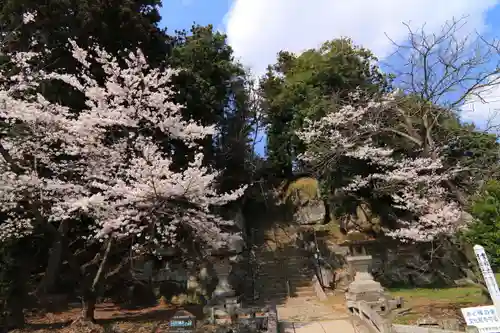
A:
465;180;500;269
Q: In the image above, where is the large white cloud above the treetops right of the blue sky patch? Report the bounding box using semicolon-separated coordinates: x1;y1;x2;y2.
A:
225;0;499;74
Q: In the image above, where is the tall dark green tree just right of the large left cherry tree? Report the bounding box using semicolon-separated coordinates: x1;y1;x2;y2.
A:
167;25;254;190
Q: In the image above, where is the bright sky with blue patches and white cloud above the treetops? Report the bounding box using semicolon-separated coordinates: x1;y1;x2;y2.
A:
161;0;500;154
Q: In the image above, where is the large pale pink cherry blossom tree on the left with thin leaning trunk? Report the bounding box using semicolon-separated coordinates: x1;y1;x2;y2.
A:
0;15;245;318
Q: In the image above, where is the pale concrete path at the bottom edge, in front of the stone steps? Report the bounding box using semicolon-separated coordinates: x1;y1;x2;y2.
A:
280;319;357;333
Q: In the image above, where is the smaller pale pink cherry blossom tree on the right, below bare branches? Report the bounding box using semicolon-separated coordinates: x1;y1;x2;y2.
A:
297;91;462;241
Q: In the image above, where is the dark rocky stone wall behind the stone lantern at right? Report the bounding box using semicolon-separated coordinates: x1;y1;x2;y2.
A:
306;233;474;288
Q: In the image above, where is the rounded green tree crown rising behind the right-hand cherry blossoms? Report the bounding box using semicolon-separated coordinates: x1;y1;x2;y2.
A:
261;39;388;177
